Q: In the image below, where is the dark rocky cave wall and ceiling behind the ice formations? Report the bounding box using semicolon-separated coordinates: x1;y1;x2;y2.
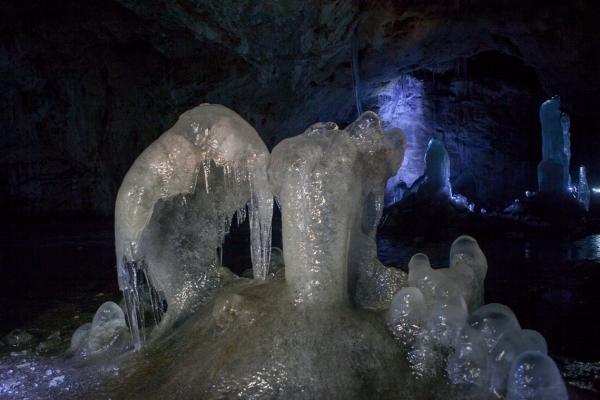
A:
0;0;600;218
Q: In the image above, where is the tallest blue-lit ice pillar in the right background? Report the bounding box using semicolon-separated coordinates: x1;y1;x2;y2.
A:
538;96;571;193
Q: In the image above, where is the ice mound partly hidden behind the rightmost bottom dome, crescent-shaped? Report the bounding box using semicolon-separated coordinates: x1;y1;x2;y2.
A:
489;329;548;396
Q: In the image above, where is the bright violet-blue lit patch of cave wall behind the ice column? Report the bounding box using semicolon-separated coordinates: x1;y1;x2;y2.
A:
377;75;430;205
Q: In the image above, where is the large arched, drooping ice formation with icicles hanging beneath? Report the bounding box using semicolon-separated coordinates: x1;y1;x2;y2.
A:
115;104;273;348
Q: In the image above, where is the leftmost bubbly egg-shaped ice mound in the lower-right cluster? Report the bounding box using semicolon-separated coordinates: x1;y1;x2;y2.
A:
387;287;427;346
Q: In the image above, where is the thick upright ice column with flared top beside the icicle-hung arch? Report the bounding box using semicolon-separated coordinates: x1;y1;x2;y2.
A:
269;112;404;303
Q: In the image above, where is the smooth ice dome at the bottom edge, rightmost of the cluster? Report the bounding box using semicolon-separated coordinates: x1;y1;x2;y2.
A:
506;351;569;400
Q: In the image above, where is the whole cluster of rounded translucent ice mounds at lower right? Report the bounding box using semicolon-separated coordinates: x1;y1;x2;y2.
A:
387;236;568;399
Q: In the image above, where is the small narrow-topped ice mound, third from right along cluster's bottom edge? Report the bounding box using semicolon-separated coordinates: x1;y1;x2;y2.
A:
447;325;489;387
